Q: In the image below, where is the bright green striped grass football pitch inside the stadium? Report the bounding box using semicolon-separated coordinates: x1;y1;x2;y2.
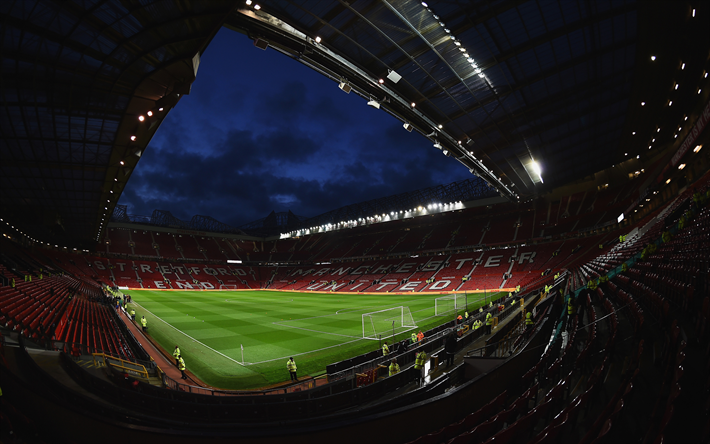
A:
128;290;502;390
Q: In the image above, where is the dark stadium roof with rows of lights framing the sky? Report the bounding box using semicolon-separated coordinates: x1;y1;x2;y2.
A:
0;0;710;248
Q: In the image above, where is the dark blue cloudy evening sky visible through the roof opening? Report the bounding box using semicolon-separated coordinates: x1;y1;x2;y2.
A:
119;28;472;226
